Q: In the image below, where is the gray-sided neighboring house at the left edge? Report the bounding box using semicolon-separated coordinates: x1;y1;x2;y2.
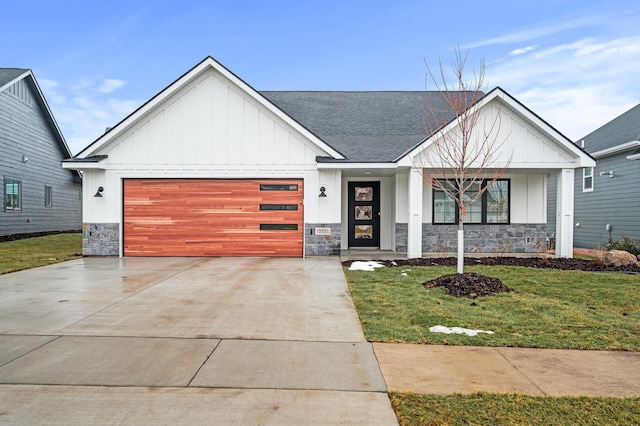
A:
0;68;82;239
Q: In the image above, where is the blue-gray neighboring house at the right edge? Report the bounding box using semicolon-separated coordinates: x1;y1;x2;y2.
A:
549;105;640;249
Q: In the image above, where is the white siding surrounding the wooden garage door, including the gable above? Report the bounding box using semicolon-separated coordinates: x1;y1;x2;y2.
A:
84;68;340;222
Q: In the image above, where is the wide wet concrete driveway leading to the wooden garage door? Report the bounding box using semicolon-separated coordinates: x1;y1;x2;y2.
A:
0;258;397;425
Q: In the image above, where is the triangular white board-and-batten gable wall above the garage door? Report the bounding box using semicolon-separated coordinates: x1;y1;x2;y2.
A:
104;70;326;170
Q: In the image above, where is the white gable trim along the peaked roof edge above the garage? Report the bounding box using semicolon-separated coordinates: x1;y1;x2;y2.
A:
76;56;344;159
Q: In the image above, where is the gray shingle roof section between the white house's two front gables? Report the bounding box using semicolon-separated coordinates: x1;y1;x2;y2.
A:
260;91;460;162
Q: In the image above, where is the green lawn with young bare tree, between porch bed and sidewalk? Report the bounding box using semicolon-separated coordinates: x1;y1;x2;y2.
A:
345;266;640;351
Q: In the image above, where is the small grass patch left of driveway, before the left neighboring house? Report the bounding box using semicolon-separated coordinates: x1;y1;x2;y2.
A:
0;233;82;274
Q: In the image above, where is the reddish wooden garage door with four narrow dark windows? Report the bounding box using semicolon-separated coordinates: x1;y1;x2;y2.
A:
124;179;304;257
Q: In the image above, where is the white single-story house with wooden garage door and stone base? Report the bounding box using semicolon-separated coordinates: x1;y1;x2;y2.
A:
63;57;595;258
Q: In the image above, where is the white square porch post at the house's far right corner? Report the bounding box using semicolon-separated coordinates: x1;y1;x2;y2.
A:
556;169;575;258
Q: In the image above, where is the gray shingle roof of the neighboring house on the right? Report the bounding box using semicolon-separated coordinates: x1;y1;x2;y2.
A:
576;104;640;154
